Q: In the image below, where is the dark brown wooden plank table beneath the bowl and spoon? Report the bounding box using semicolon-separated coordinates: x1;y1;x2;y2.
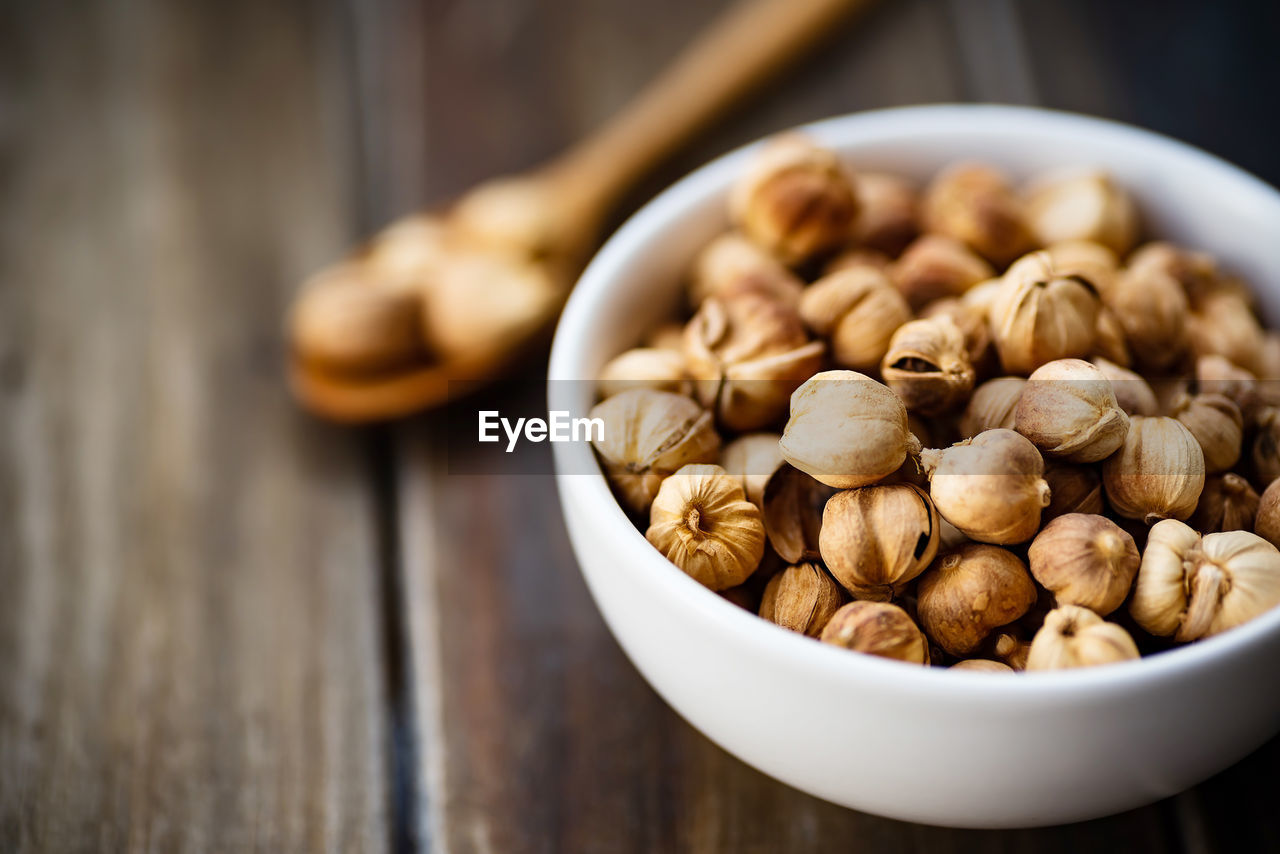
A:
0;0;1280;854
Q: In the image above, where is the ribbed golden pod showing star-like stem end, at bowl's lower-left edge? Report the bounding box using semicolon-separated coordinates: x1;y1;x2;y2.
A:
645;465;764;590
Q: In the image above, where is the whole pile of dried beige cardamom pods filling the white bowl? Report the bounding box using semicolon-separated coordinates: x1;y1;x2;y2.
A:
591;134;1280;671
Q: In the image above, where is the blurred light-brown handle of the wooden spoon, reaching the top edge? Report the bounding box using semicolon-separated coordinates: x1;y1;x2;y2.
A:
544;0;872;229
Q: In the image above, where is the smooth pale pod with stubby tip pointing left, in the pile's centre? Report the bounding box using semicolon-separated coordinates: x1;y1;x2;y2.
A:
920;430;1050;544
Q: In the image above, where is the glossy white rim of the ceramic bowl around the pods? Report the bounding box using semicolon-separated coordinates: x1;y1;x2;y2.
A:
548;104;1280;703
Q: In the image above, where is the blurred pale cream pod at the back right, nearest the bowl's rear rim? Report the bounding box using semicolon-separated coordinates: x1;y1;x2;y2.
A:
1027;172;1138;255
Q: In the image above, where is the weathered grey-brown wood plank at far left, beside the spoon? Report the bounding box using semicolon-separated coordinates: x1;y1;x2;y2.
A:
0;1;389;851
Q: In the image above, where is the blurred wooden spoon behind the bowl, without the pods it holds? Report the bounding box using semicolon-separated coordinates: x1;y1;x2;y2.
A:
288;0;869;423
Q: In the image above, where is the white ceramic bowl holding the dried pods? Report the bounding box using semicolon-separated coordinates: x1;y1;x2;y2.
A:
549;105;1280;827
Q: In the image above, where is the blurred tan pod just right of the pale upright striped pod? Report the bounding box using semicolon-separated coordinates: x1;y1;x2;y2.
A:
1102;269;1189;370
